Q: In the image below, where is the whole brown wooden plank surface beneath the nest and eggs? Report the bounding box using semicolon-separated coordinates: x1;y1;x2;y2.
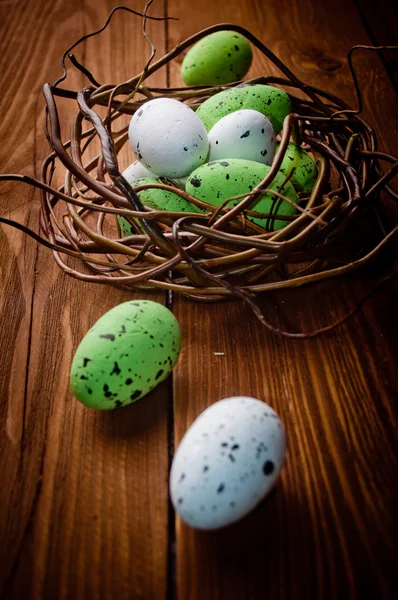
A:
0;0;398;600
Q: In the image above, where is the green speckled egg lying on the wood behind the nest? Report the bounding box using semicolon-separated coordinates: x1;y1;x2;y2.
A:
181;31;252;85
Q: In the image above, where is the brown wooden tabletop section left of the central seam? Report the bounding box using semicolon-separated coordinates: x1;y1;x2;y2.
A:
0;0;170;600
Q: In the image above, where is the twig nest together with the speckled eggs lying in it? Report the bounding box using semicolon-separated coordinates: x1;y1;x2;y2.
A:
0;17;388;328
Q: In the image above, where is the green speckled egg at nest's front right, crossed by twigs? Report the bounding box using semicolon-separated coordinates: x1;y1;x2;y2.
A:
186;158;297;231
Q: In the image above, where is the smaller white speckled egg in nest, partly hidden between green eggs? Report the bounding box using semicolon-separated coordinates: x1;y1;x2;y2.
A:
208;109;276;165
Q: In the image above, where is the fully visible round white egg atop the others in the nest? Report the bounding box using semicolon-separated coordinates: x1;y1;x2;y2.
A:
129;98;209;178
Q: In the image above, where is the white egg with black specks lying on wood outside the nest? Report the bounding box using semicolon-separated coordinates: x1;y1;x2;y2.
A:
170;396;286;529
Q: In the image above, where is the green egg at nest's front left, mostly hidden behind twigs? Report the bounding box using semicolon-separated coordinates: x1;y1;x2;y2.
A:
117;177;203;237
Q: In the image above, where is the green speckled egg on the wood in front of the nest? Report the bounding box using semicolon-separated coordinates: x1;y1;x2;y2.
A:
70;300;181;410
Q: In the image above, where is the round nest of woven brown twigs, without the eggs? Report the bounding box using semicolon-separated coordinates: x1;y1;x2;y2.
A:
2;9;397;336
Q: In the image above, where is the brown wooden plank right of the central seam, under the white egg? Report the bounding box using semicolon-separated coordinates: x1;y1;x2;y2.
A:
169;0;398;600
